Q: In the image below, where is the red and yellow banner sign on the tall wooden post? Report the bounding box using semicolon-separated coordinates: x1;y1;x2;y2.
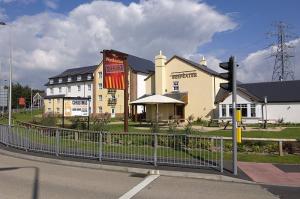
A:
103;50;126;90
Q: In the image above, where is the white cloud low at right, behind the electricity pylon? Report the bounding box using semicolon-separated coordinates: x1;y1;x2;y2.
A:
238;39;300;82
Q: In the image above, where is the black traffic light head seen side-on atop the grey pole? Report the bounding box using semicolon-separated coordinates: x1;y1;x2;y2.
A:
219;56;235;92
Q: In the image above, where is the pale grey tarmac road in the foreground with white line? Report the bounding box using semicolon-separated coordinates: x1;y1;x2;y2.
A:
0;155;277;199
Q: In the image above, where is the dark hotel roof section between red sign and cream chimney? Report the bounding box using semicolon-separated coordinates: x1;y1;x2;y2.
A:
127;55;155;74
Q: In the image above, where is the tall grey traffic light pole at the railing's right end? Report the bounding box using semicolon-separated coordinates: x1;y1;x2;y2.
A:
232;57;237;175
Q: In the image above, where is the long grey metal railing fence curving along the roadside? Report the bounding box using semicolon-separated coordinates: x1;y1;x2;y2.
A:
0;125;223;171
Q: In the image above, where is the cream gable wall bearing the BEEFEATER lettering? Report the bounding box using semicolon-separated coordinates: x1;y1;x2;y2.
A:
165;58;221;120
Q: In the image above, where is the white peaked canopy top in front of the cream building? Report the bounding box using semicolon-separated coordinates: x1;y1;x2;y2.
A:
130;95;184;105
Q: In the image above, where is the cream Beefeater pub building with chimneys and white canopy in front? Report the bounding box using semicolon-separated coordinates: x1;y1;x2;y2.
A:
130;51;226;122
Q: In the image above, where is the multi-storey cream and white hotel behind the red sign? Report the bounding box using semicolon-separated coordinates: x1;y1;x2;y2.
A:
44;55;154;117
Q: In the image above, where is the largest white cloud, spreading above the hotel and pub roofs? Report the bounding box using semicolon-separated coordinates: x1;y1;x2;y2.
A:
0;0;236;86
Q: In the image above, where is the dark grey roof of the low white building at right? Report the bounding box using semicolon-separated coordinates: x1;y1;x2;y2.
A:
215;80;300;103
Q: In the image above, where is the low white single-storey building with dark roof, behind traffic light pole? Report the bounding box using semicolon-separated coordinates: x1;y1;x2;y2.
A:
215;80;300;123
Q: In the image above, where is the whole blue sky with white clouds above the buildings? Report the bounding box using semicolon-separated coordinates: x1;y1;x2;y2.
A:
0;0;300;88
